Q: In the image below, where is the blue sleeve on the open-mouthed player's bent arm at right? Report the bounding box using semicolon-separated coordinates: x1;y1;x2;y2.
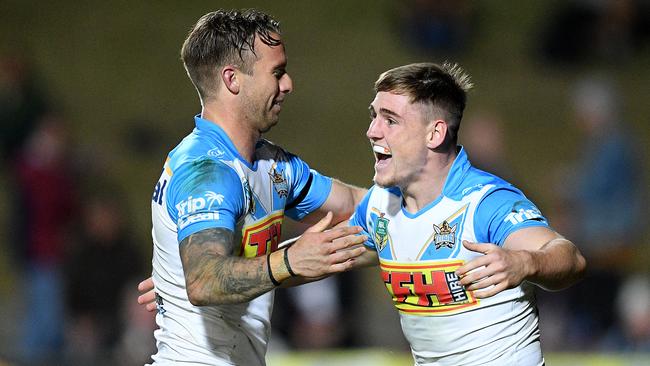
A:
474;188;548;246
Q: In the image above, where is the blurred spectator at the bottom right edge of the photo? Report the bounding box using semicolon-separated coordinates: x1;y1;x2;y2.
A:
601;274;650;353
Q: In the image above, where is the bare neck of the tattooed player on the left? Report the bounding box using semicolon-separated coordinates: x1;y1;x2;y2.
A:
201;103;262;163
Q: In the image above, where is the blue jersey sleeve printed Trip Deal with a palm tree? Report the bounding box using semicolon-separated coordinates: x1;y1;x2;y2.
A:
167;158;244;243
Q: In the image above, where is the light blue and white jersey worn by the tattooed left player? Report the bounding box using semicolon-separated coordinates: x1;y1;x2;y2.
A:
151;116;332;365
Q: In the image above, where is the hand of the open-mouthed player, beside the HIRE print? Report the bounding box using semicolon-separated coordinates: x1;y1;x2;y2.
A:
456;240;528;299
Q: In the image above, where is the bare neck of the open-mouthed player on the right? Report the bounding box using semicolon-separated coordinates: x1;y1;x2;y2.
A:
400;148;458;213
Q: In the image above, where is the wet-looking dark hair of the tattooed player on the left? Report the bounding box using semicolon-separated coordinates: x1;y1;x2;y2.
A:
181;9;281;98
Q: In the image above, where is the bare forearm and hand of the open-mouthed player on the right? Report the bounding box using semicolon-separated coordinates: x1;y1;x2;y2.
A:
456;227;586;298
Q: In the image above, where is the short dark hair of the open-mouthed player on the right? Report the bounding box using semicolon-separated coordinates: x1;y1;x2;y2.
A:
375;62;473;143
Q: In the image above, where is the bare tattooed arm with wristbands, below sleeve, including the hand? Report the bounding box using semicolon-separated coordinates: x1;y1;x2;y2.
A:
180;213;365;306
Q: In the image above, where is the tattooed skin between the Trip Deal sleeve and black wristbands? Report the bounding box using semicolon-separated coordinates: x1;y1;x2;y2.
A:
180;228;274;305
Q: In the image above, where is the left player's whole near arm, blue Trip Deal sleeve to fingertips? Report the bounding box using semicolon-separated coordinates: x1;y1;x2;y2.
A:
167;158;365;305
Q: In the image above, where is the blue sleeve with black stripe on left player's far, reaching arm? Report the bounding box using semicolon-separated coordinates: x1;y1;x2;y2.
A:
285;153;332;220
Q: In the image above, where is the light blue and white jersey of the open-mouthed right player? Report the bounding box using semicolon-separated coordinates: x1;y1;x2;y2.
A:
350;149;548;366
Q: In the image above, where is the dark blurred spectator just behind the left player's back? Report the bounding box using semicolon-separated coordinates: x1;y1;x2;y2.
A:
66;190;144;365
